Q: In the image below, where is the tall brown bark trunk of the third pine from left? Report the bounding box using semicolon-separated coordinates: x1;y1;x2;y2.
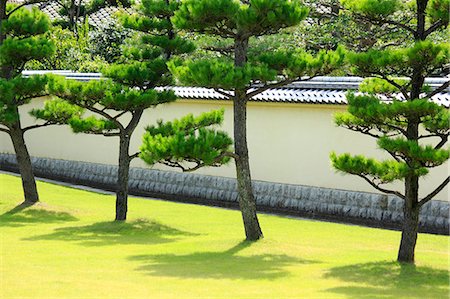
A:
234;35;263;241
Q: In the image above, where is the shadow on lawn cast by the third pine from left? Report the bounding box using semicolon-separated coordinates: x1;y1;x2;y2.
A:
129;241;315;280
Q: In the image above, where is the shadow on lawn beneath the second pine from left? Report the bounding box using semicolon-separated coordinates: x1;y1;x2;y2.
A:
25;219;195;246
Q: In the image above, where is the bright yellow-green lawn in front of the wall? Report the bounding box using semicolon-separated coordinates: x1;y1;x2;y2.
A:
0;175;449;299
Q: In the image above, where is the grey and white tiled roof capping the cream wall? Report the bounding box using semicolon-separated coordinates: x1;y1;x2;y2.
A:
24;71;450;108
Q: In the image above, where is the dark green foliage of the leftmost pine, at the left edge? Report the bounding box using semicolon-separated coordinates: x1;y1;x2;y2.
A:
0;6;76;128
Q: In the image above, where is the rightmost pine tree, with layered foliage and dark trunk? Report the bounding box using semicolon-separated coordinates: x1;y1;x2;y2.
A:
331;0;450;263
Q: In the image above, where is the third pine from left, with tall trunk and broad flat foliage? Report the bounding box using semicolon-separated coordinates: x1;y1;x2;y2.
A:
169;0;343;240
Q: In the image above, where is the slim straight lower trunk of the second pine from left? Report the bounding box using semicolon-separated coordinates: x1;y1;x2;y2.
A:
115;134;131;221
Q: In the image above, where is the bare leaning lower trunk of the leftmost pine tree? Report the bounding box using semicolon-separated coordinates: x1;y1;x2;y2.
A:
9;123;39;204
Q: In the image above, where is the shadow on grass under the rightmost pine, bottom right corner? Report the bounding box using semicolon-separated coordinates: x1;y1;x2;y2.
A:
325;262;450;299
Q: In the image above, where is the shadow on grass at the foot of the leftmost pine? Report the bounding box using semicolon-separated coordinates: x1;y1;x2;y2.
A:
0;202;78;227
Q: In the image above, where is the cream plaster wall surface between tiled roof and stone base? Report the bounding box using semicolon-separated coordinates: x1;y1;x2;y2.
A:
0;99;449;200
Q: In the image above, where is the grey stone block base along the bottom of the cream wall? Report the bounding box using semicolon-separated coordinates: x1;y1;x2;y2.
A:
0;154;450;235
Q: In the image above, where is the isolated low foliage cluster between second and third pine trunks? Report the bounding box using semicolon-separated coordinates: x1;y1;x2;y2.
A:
140;110;233;171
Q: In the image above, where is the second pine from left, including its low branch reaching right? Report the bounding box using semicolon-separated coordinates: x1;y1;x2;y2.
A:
50;0;228;220
